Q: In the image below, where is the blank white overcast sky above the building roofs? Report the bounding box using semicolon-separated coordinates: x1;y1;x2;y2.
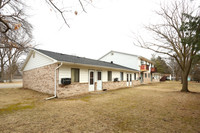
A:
25;0;169;59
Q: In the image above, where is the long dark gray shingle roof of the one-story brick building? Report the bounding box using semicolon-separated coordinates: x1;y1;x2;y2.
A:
35;49;138;71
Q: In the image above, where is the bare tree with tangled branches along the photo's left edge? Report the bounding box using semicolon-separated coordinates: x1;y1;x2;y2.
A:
0;0;32;80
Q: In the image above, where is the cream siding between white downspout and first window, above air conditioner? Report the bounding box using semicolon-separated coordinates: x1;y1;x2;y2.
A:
59;65;71;84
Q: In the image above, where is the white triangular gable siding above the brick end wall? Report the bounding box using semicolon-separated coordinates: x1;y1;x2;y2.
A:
24;52;55;71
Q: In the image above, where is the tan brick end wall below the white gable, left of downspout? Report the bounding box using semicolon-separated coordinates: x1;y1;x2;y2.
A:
23;64;57;94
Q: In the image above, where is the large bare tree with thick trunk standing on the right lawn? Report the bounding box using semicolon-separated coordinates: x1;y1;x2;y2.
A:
134;0;199;92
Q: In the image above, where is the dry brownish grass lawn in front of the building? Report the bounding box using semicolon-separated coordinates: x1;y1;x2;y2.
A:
0;82;200;133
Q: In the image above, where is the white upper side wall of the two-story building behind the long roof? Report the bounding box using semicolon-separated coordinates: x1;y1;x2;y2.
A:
100;52;140;70
